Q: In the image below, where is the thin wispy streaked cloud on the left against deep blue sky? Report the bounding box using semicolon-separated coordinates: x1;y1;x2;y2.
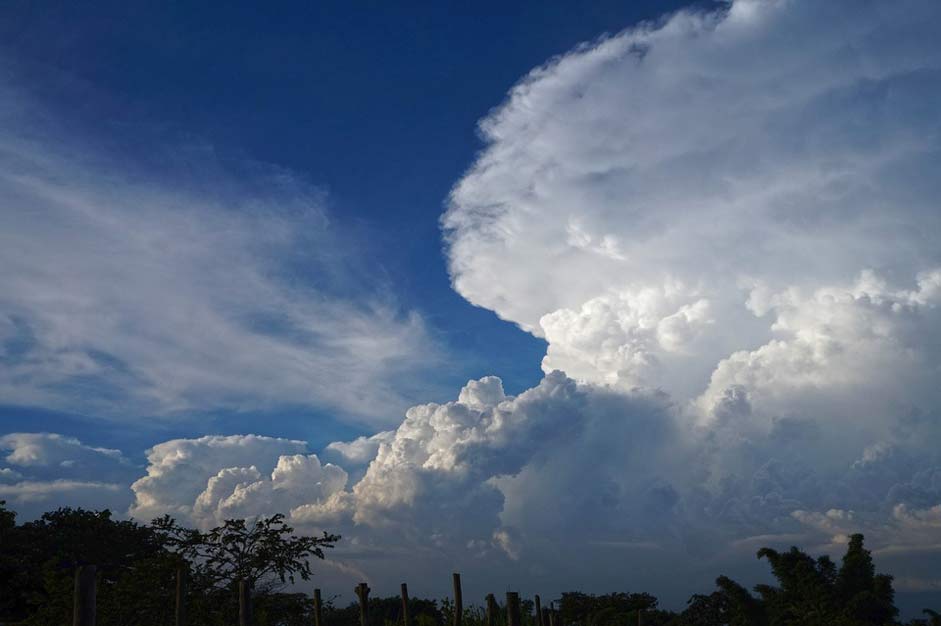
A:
0;72;439;423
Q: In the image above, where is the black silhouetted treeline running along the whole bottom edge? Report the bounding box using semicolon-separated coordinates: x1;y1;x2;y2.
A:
0;502;941;626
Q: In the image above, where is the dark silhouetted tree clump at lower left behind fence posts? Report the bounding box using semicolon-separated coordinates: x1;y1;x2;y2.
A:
0;502;339;626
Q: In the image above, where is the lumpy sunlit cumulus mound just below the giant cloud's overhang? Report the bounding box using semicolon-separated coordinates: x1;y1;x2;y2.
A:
353;373;582;524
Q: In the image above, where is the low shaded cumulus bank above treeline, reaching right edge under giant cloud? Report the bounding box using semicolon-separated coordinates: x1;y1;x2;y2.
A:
16;372;941;601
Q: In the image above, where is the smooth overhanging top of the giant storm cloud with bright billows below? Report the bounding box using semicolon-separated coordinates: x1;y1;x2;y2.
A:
442;0;941;396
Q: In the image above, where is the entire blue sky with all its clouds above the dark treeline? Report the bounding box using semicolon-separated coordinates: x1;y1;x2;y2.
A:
0;0;941;609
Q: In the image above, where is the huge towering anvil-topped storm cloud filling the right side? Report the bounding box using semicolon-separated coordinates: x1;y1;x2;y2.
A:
442;0;941;596
